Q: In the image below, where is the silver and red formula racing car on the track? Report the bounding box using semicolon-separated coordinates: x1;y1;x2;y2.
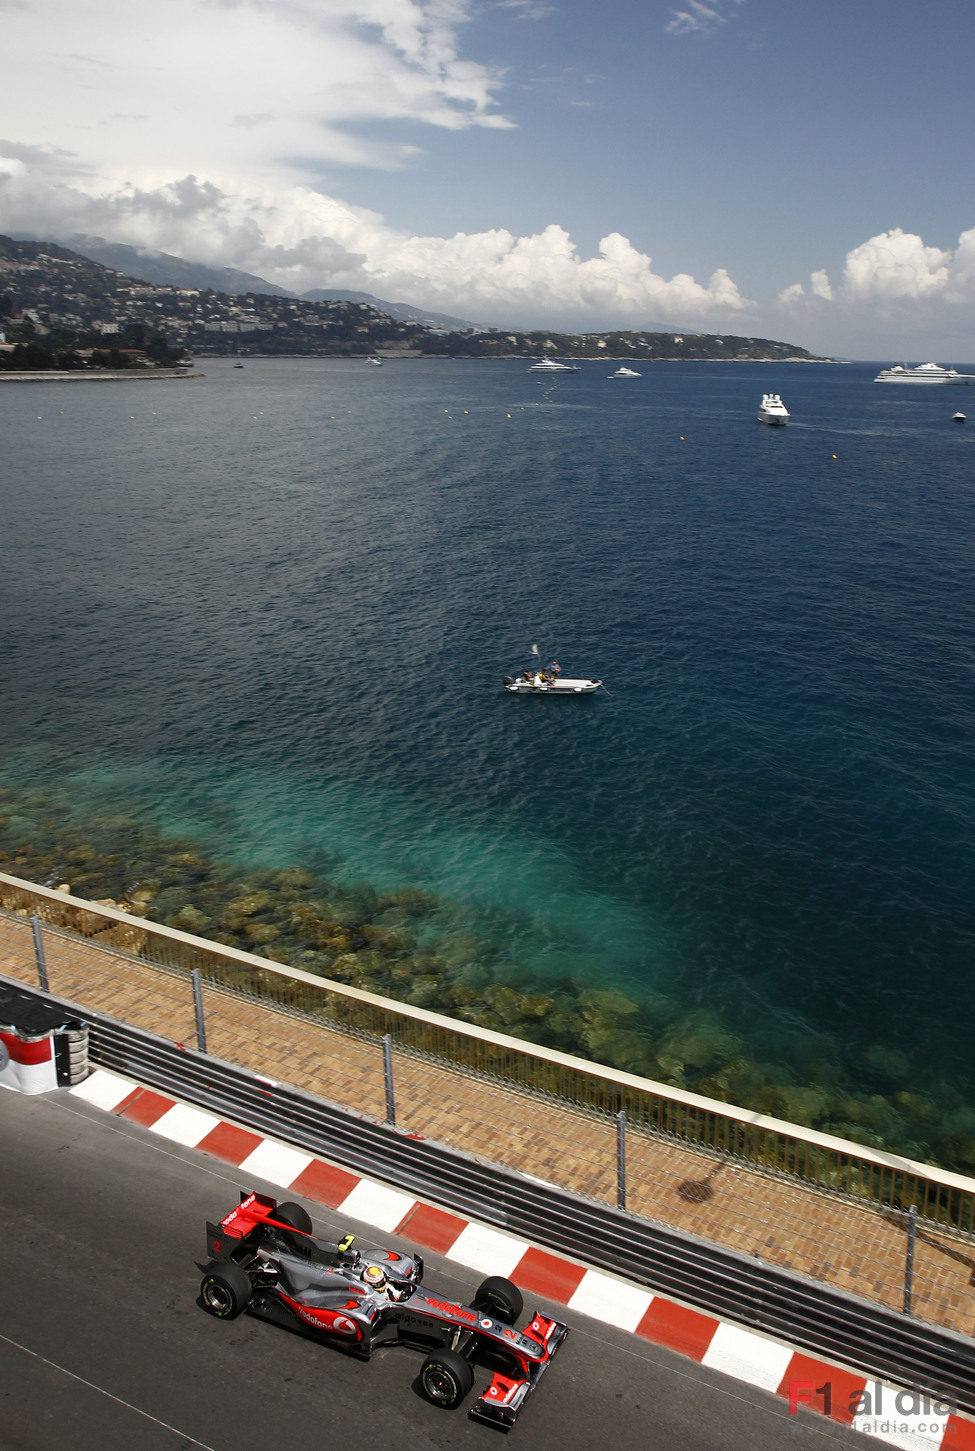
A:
200;1193;569;1431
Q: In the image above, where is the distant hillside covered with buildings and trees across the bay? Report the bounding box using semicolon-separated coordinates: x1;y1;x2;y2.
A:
0;237;813;371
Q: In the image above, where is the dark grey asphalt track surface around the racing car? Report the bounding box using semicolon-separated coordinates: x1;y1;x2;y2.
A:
0;1090;871;1451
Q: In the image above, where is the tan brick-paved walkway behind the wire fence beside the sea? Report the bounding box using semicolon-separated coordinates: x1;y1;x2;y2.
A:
0;914;975;1335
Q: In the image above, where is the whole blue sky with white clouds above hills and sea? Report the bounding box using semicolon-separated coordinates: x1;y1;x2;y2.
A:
0;0;975;364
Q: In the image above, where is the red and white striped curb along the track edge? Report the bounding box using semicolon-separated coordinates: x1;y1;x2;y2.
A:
70;1068;975;1451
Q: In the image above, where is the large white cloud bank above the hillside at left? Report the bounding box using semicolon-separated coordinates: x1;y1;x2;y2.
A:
0;0;747;326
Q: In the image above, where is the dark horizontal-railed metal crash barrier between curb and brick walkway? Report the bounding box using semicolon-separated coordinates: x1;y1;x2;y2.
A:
11;975;975;1412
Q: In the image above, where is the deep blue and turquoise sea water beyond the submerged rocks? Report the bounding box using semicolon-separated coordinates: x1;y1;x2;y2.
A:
0;358;975;1133
